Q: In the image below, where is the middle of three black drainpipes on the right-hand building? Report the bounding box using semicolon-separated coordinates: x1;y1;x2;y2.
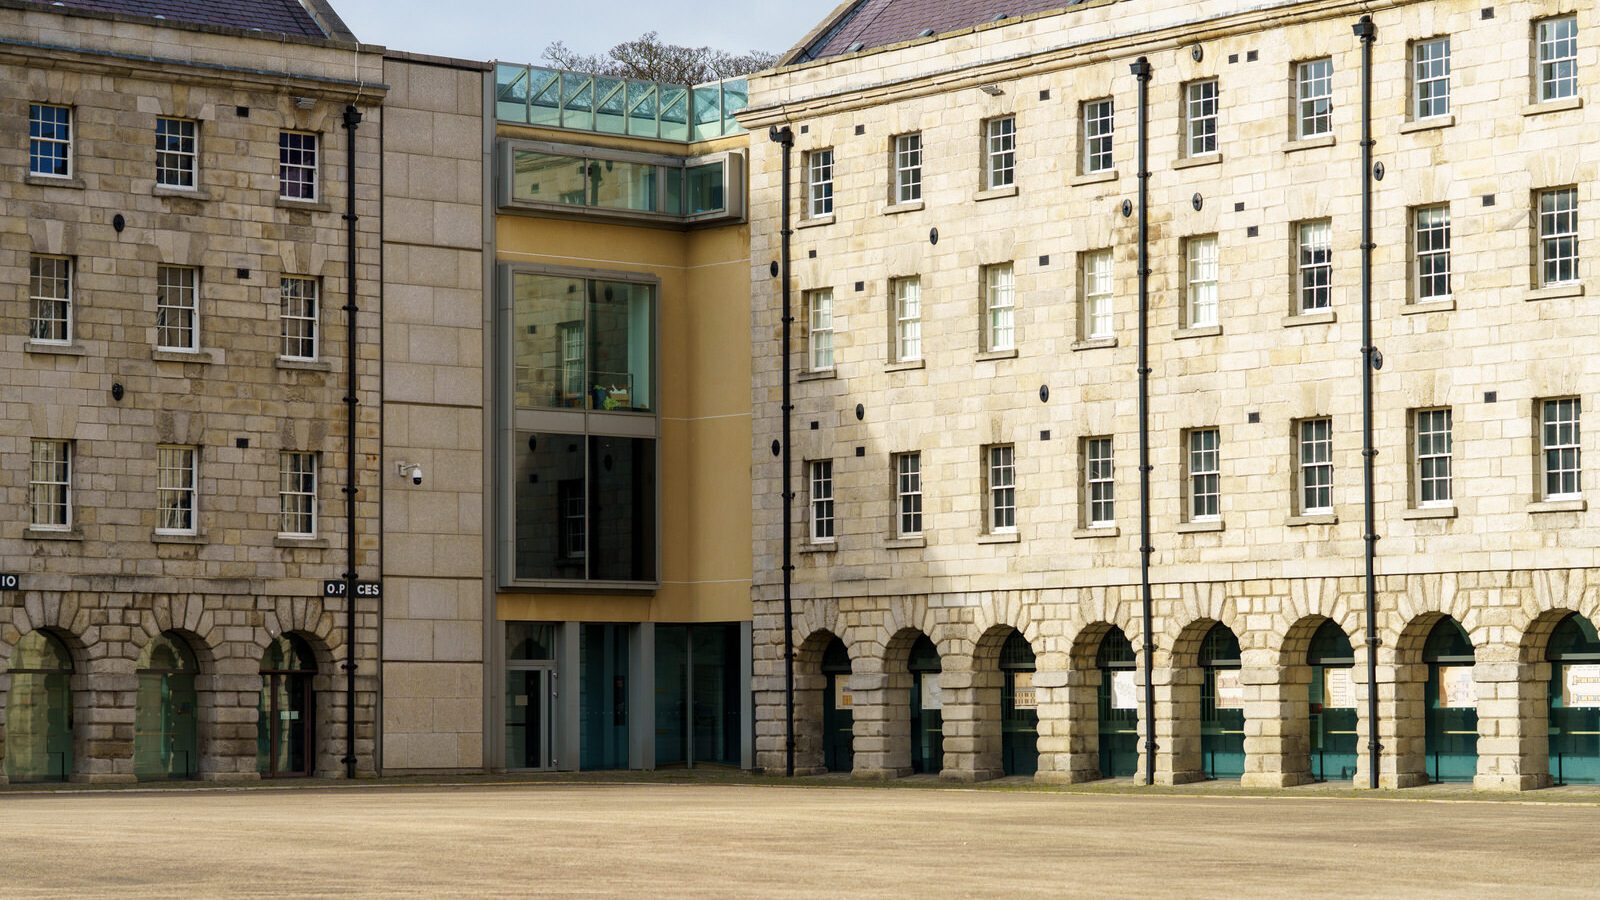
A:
1131;56;1157;785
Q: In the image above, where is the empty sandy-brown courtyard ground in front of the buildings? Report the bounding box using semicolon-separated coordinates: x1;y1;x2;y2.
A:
0;783;1600;898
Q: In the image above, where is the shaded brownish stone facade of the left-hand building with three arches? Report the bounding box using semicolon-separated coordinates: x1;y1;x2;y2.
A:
0;0;384;781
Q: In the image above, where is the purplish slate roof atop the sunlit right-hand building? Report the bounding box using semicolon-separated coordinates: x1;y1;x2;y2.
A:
792;0;1083;62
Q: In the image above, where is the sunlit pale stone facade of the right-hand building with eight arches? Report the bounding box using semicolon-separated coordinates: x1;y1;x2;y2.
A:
742;0;1600;790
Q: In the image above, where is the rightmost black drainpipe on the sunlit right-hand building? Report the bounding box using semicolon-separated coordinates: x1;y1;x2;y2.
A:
1354;16;1384;790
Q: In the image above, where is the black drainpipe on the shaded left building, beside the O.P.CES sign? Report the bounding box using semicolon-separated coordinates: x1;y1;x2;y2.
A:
344;104;362;778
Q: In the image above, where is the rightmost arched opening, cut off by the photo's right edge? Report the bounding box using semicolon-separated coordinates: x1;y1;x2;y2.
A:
1544;613;1600;785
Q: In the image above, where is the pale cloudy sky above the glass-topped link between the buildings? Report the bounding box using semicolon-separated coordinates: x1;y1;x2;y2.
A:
331;0;838;62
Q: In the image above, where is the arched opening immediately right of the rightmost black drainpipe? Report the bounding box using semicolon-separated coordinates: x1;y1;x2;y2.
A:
1422;617;1478;781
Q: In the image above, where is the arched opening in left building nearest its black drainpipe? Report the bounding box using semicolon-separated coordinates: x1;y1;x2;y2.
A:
256;634;317;778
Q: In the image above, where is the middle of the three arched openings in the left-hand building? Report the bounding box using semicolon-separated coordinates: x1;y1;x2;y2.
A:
133;631;200;781
